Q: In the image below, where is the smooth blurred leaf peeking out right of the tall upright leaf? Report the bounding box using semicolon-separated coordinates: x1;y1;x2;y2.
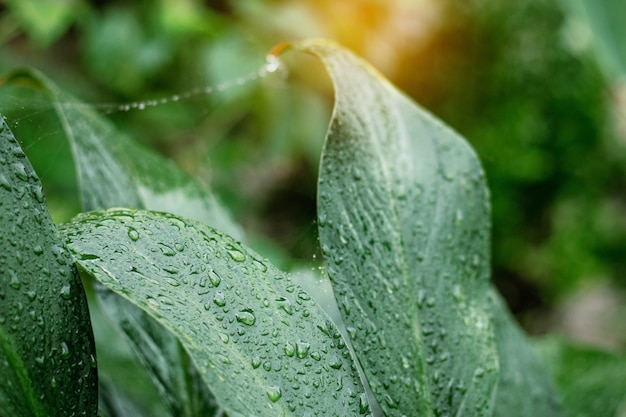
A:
492;290;563;417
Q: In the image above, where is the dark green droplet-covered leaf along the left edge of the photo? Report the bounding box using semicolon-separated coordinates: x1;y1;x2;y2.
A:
0;117;98;417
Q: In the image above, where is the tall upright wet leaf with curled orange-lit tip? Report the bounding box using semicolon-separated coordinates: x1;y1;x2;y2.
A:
302;41;498;416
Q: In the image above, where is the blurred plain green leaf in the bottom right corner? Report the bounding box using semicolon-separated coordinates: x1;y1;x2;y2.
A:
537;337;626;417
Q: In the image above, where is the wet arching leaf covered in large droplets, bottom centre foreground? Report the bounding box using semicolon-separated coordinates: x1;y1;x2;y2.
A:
61;209;368;417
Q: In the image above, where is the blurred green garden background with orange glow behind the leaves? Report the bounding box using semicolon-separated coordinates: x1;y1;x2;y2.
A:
0;0;626;349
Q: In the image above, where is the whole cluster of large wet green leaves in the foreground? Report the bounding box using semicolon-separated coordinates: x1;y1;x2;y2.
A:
0;41;626;417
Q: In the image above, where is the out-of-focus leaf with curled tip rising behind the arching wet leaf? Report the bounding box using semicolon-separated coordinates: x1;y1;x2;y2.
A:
0;70;242;238
